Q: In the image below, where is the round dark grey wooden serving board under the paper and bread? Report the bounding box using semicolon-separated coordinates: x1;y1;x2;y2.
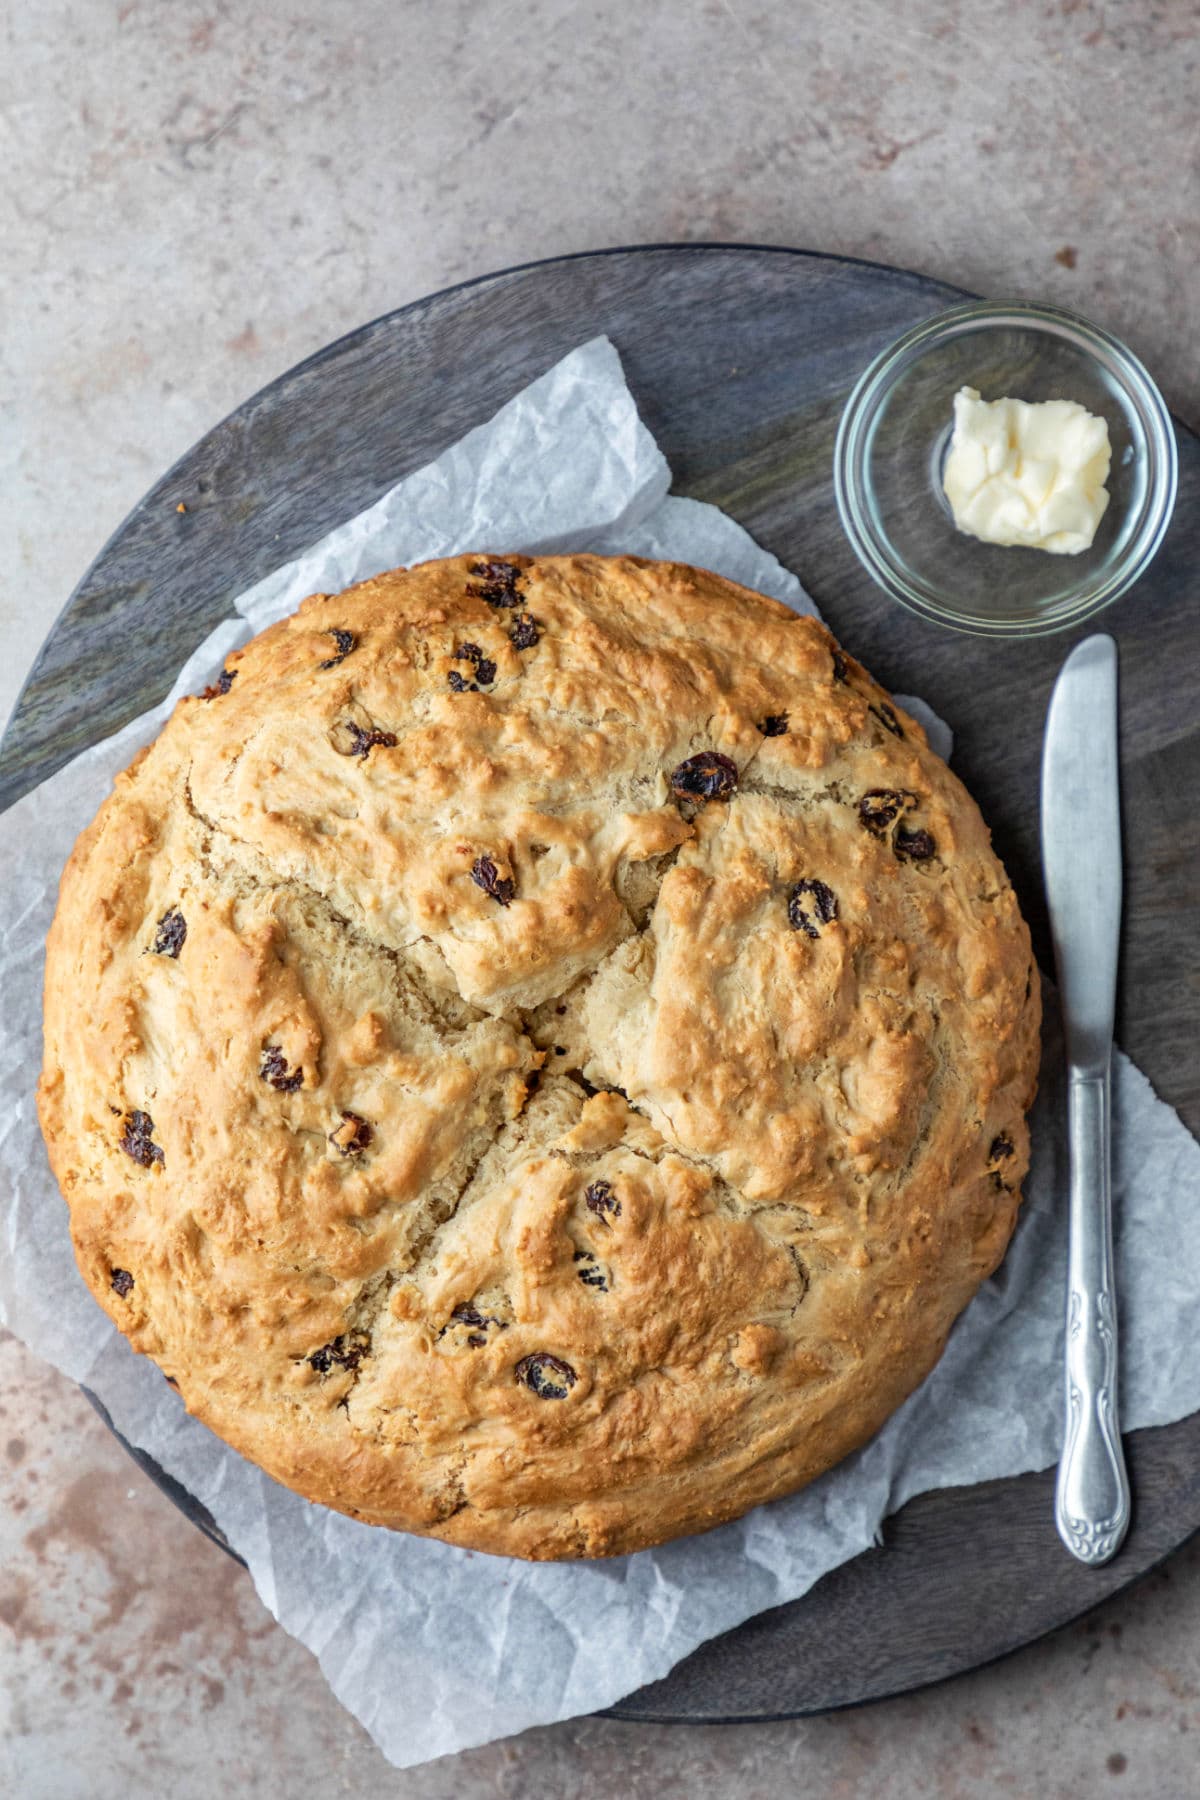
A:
0;245;1200;1721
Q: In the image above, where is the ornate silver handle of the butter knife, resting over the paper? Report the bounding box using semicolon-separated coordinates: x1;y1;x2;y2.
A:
1054;1067;1130;1564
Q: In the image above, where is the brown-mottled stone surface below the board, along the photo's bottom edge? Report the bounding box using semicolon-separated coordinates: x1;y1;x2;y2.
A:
0;1336;1200;1800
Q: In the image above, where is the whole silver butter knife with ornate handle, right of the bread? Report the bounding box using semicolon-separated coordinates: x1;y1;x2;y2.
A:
1042;634;1130;1564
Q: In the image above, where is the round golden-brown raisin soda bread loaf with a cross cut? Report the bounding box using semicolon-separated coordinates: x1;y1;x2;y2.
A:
40;556;1038;1557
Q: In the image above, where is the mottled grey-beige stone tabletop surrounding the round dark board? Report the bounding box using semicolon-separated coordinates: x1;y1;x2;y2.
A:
0;0;1200;1800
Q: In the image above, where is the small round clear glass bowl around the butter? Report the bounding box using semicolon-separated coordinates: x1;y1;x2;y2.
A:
833;301;1178;637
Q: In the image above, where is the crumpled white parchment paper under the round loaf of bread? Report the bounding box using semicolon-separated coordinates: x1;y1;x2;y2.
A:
0;338;1200;1766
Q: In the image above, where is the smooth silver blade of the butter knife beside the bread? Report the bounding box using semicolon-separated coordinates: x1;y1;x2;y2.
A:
1042;634;1121;1069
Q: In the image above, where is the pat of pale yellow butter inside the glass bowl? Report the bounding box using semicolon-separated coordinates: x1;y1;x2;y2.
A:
943;387;1112;556
